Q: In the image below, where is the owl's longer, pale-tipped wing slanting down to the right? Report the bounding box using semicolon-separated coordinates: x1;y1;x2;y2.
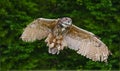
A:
64;25;110;62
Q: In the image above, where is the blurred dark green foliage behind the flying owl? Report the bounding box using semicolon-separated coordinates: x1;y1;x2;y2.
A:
0;0;120;71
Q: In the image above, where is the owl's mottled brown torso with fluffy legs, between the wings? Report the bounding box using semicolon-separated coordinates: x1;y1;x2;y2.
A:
45;17;70;54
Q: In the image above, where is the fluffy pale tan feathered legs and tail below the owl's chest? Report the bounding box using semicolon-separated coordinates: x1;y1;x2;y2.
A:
45;33;67;54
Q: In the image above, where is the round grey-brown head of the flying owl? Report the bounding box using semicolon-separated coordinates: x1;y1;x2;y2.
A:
59;17;72;28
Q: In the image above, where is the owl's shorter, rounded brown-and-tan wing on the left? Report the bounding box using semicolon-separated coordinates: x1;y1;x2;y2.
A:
21;18;58;42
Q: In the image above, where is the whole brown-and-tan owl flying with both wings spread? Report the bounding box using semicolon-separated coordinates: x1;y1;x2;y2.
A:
21;17;111;62
